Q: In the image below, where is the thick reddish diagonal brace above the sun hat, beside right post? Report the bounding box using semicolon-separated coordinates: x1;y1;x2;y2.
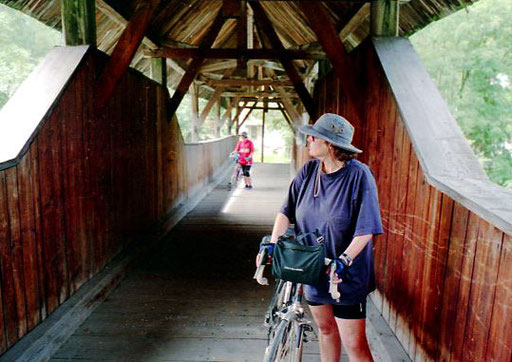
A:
297;1;363;119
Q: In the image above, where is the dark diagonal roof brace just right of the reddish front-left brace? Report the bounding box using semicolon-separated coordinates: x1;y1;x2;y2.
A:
169;11;224;119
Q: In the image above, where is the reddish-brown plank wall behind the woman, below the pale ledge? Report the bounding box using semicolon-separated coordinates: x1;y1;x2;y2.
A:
314;42;512;361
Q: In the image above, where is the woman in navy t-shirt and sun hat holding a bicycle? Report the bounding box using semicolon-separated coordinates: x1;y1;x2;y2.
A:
271;113;382;361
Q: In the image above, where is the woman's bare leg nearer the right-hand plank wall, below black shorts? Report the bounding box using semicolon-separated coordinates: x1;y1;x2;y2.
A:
336;318;373;362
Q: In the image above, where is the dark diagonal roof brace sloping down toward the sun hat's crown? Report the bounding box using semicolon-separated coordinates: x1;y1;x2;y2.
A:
251;2;316;119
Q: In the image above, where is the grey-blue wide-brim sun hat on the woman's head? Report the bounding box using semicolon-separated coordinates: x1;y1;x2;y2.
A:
299;113;363;153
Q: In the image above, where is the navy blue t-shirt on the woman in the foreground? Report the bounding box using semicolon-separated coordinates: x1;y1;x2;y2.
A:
281;160;382;305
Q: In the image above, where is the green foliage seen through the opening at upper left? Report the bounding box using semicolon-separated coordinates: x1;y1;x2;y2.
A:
0;5;61;108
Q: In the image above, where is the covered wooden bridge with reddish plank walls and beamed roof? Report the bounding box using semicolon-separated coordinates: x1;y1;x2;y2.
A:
0;0;512;361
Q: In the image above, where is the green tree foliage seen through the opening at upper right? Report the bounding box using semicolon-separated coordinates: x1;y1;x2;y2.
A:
411;0;512;188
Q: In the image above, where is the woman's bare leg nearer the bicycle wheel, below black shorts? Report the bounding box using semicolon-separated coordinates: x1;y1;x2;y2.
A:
309;304;341;362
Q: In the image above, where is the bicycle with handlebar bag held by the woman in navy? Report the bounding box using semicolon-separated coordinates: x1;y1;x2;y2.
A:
254;235;340;362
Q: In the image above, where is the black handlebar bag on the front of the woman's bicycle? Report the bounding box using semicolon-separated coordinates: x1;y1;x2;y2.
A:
272;233;325;285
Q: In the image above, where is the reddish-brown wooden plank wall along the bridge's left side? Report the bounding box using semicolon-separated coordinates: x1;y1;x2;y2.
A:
0;50;234;354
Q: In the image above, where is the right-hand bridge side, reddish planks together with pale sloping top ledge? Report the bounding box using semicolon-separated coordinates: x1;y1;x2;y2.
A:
306;38;512;361
